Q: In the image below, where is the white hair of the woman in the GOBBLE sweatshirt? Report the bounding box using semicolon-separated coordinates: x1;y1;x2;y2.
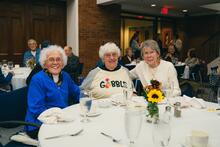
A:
99;42;121;59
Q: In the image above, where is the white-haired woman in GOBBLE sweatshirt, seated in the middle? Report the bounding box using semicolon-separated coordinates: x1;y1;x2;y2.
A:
80;42;132;98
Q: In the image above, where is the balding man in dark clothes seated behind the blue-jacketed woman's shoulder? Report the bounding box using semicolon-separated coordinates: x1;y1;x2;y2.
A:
64;46;79;83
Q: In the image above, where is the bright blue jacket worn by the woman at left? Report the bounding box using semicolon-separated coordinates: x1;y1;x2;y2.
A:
25;71;80;131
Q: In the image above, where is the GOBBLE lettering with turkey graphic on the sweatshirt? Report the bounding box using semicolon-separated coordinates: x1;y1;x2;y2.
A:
100;78;128;88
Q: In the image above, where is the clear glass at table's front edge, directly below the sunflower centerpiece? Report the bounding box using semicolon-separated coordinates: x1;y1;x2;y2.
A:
152;120;171;147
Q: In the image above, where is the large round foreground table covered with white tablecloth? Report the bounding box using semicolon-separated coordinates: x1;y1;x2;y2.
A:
38;100;220;147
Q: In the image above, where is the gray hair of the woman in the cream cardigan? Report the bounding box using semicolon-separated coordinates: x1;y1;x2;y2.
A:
141;39;160;57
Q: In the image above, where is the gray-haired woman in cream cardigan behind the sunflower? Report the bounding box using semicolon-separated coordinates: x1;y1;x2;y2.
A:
130;40;181;97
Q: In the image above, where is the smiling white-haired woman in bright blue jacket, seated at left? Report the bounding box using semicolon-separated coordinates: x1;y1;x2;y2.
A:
25;45;80;138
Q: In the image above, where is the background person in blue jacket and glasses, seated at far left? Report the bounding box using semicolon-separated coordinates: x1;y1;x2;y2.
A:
23;39;40;66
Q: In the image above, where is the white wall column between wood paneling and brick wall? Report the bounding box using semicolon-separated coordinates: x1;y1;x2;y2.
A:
67;0;79;56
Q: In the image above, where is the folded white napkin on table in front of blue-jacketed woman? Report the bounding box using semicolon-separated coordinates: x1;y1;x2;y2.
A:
38;107;74;124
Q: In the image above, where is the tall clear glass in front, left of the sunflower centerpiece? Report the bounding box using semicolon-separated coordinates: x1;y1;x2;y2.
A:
125;108;143;146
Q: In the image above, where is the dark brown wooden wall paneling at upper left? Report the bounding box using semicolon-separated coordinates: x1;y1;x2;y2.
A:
0;0;66;63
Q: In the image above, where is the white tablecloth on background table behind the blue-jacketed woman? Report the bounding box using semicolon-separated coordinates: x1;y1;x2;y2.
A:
11;67;31;90
